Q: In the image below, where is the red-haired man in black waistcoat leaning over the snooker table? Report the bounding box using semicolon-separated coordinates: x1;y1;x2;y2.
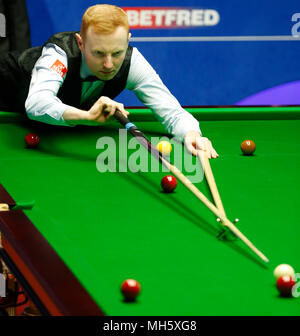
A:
0;5;218;158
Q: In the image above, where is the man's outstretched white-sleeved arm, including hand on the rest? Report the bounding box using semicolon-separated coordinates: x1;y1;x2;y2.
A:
126;48;218;158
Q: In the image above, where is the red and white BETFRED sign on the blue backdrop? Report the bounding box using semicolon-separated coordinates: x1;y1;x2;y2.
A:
123;7;220;29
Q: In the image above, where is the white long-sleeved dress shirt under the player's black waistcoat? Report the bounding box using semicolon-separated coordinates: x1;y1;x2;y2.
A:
25;43;200;141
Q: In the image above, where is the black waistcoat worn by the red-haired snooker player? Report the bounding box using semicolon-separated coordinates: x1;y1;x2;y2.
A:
0;32;132;111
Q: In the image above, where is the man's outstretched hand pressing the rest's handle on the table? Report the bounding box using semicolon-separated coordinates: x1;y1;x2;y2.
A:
184;131;219;159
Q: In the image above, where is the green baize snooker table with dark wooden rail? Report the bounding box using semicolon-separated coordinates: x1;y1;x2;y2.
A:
0;106;300;316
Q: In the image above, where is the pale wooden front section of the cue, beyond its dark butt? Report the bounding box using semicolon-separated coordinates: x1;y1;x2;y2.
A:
161;157;269;262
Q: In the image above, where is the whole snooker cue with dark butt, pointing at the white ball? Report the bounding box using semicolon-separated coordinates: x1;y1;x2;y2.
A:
114;110;269;262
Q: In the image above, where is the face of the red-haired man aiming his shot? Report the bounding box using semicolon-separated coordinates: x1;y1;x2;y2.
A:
76;27;130;81
